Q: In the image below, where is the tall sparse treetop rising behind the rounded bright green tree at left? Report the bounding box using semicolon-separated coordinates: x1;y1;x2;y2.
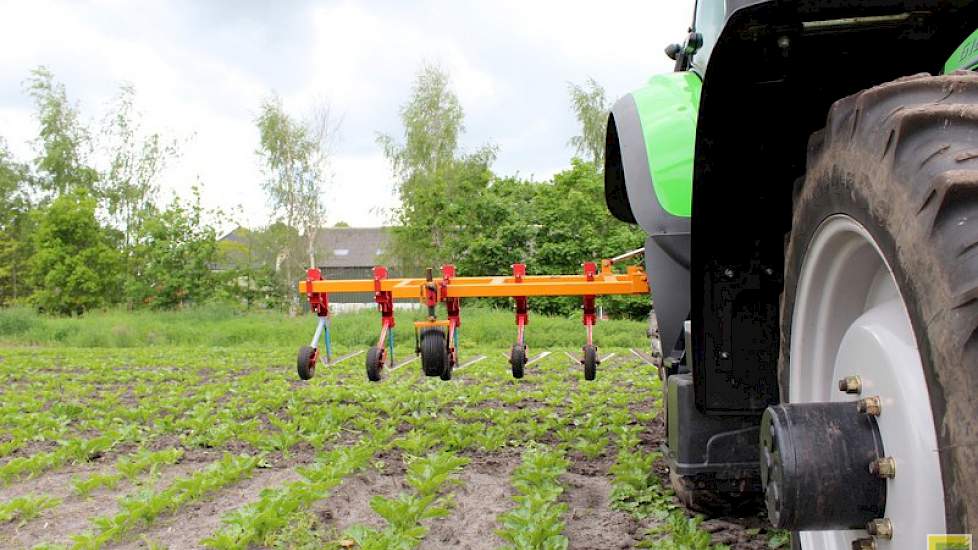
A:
27;67;98;195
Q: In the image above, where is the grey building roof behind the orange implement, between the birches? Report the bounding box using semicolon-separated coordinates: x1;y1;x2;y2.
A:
316;227;390;267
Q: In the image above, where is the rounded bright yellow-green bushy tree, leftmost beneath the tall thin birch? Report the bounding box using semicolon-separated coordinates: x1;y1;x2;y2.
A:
30;190;122;315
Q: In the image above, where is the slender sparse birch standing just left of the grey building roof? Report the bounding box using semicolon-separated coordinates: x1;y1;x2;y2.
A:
256;96;337;308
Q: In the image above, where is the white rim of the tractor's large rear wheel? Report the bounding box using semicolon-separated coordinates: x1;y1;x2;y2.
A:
788;215;946;550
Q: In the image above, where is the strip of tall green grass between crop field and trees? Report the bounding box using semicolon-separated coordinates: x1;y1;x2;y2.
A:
0;306;646;349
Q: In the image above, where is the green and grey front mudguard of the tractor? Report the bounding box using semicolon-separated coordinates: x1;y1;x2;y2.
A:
605;71;702;354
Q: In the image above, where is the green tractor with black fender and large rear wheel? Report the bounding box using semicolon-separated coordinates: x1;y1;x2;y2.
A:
605;0;978;550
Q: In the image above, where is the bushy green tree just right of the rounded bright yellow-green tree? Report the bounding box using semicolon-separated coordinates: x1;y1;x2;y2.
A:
130;188;217;309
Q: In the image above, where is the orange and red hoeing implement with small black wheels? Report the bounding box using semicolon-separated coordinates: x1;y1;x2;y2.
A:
297;254;649;382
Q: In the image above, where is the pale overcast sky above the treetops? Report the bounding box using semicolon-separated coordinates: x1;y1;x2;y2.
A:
0;0;693;229
